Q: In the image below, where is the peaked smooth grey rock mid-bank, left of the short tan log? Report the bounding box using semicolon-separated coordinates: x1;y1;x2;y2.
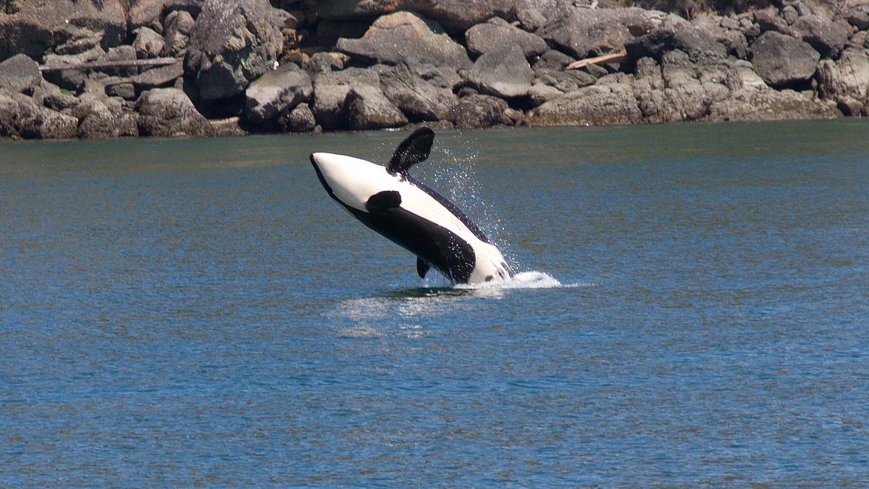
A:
468;44;534;98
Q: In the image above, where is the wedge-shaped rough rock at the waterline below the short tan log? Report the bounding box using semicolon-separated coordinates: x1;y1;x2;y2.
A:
527;74;643;126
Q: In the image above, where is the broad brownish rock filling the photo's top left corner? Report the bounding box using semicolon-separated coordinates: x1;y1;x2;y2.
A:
0;0;127;60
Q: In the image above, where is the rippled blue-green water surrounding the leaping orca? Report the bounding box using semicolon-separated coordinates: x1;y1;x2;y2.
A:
0;121;869;488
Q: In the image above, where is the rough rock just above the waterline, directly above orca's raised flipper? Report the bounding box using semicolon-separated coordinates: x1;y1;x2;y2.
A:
380;65;459;122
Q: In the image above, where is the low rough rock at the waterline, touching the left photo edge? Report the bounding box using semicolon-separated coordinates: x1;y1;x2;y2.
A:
0;90;78;139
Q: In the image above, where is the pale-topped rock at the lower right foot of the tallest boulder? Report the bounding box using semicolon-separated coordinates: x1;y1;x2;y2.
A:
244;63;314;125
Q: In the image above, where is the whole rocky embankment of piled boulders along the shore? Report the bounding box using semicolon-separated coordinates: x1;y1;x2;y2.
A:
0;0;869;138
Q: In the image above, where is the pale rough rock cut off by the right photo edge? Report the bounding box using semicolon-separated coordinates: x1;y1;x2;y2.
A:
818;48;869;104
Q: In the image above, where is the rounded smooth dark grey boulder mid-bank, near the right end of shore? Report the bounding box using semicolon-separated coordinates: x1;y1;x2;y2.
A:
751;31;821;88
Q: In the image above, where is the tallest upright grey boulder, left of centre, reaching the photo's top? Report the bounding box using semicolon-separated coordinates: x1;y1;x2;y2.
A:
184;0;289;101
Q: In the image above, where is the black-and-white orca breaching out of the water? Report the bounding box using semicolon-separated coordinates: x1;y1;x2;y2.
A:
311;127;510;284
